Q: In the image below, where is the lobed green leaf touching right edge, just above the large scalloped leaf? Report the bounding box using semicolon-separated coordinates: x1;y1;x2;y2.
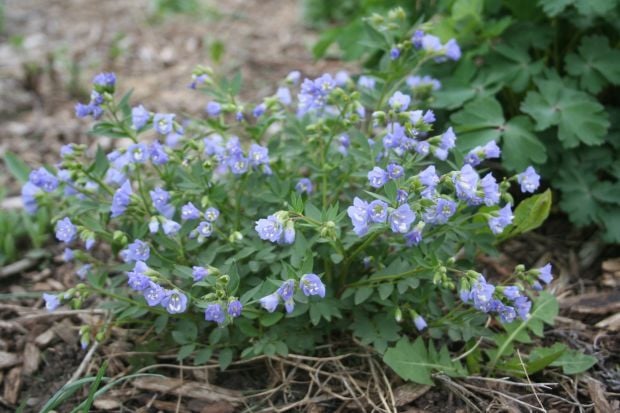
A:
564;35;620;93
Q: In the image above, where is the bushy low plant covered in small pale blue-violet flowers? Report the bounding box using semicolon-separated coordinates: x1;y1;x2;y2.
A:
23;10;592;383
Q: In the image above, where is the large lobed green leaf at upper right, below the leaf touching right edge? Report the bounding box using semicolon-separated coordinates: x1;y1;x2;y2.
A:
521;80;609;148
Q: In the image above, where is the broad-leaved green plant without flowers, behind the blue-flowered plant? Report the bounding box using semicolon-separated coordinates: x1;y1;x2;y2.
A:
315;0;620;243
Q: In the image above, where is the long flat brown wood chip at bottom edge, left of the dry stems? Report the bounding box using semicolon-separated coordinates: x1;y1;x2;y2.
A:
132;377;243;406
